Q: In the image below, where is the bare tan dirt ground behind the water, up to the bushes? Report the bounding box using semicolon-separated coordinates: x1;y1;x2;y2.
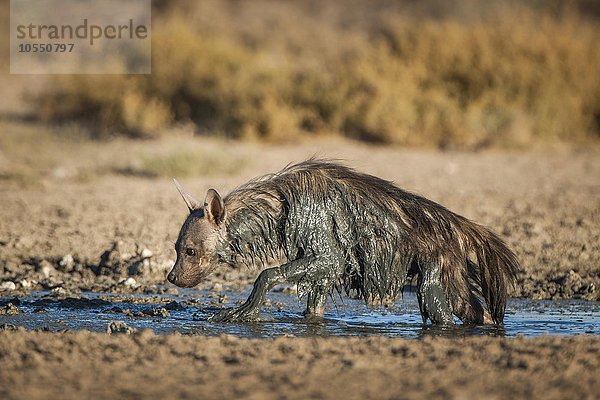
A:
0;124;600;300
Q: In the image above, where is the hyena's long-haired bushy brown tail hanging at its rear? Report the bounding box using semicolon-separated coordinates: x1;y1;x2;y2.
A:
442;221;520;324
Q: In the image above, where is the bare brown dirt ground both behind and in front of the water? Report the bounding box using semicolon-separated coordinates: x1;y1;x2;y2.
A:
0;121;600;400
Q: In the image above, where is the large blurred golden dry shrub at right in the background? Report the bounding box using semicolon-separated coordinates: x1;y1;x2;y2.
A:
342;11;600;147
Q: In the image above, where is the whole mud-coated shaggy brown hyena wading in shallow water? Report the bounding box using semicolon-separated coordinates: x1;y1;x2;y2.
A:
168;159;519;324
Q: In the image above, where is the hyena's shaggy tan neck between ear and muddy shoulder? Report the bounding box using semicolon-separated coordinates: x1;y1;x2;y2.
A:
217;193;284;267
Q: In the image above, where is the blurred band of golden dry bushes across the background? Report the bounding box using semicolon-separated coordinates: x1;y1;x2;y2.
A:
1;0;600;149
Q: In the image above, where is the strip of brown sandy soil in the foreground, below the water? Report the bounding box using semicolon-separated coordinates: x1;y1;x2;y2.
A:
0;331;600;400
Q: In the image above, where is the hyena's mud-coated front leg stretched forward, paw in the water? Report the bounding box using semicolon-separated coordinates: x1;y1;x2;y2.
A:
211;257;327;322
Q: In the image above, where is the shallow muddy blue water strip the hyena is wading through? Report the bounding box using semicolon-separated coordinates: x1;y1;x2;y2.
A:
0;290;600;338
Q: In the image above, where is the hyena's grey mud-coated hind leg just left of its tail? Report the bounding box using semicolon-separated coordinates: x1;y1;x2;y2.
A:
417;263;454;325
